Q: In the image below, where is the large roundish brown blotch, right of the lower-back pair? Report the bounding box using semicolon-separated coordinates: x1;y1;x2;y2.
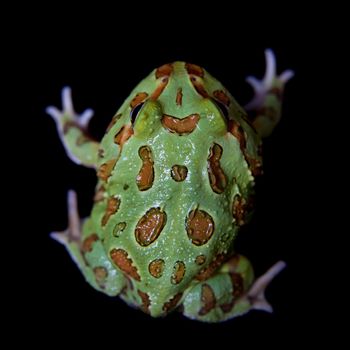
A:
186;209;214;245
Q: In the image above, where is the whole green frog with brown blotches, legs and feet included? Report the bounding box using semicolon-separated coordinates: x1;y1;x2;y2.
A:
46;49;293;323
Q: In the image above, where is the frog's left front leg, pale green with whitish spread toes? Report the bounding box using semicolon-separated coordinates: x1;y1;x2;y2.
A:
46;87;99;168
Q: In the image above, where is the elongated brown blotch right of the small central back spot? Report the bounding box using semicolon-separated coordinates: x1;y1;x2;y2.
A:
208;143;227;193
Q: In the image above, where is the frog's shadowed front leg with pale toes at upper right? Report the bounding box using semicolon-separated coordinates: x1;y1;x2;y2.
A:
245;50;294;137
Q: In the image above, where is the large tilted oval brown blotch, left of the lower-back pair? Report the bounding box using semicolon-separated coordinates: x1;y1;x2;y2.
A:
135;208;167;247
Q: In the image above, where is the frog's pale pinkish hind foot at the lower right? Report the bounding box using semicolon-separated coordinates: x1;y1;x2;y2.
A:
245;261;286;312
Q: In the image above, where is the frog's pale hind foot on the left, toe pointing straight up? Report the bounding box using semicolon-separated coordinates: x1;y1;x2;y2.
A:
51;190;81;245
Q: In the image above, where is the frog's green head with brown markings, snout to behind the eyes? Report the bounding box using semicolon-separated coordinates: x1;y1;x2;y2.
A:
116;62;253;137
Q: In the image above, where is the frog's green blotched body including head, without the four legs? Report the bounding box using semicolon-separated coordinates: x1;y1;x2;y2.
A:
92;62;261;316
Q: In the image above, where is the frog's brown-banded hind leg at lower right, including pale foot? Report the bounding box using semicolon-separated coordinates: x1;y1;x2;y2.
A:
183;255;285;322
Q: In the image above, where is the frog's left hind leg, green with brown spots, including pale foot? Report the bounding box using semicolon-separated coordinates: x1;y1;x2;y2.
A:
51;191;125;296
